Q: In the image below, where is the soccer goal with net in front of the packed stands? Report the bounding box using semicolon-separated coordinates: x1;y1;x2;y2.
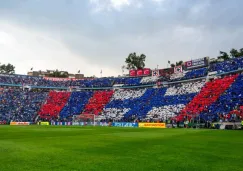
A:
73;114;96;126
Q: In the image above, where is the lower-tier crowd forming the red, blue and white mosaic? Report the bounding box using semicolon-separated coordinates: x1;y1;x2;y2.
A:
0;74;243;121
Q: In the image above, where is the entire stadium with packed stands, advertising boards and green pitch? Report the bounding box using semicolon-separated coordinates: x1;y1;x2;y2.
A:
0;54;243;170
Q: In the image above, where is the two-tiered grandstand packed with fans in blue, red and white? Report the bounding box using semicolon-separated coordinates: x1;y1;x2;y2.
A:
0;57;243;125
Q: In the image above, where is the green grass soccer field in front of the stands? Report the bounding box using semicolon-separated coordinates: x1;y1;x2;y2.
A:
0;126;243;171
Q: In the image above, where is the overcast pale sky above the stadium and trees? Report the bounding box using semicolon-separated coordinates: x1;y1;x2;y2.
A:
0;0;243;76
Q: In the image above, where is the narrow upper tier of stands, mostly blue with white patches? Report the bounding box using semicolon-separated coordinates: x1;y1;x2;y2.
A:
0;57;243;89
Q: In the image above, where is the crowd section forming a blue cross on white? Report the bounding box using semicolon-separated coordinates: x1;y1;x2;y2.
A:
103;80;205;120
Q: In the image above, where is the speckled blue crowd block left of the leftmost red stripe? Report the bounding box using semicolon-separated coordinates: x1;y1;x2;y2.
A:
0;88;48;122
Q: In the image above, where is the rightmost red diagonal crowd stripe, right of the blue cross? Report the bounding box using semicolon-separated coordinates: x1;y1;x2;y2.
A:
180;75;238;117
